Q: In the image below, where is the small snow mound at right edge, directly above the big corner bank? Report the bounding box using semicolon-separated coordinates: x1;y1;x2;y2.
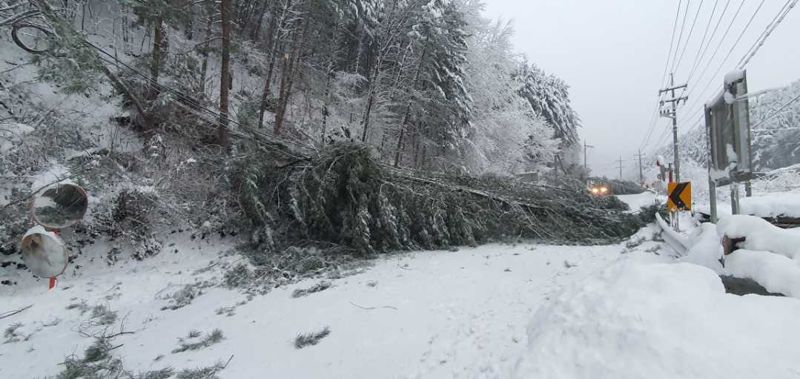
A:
725;250;800;298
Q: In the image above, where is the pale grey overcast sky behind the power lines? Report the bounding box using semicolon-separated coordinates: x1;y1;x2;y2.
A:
484;0;800;176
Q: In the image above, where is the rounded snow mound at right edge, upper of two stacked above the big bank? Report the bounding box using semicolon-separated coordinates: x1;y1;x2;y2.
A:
717;215;800;259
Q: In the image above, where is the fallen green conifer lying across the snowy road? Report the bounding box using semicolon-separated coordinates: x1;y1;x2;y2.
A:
233;144;645;262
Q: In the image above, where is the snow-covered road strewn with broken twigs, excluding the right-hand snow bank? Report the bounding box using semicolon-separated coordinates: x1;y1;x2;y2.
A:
0;239;636;378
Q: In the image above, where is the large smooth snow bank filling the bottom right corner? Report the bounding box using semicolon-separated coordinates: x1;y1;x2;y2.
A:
515;260;800;379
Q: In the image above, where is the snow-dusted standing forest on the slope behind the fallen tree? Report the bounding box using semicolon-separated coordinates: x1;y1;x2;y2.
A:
17;0;580;174
